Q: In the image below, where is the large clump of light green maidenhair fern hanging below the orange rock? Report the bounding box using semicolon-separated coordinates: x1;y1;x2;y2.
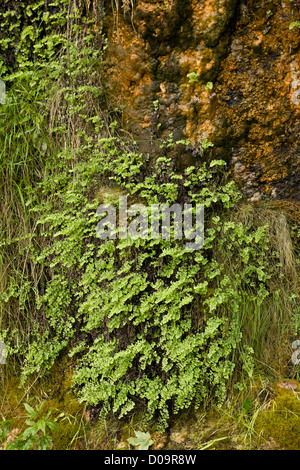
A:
19;144;267;430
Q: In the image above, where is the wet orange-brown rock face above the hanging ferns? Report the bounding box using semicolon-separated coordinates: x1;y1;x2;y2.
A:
105;0;300;201
